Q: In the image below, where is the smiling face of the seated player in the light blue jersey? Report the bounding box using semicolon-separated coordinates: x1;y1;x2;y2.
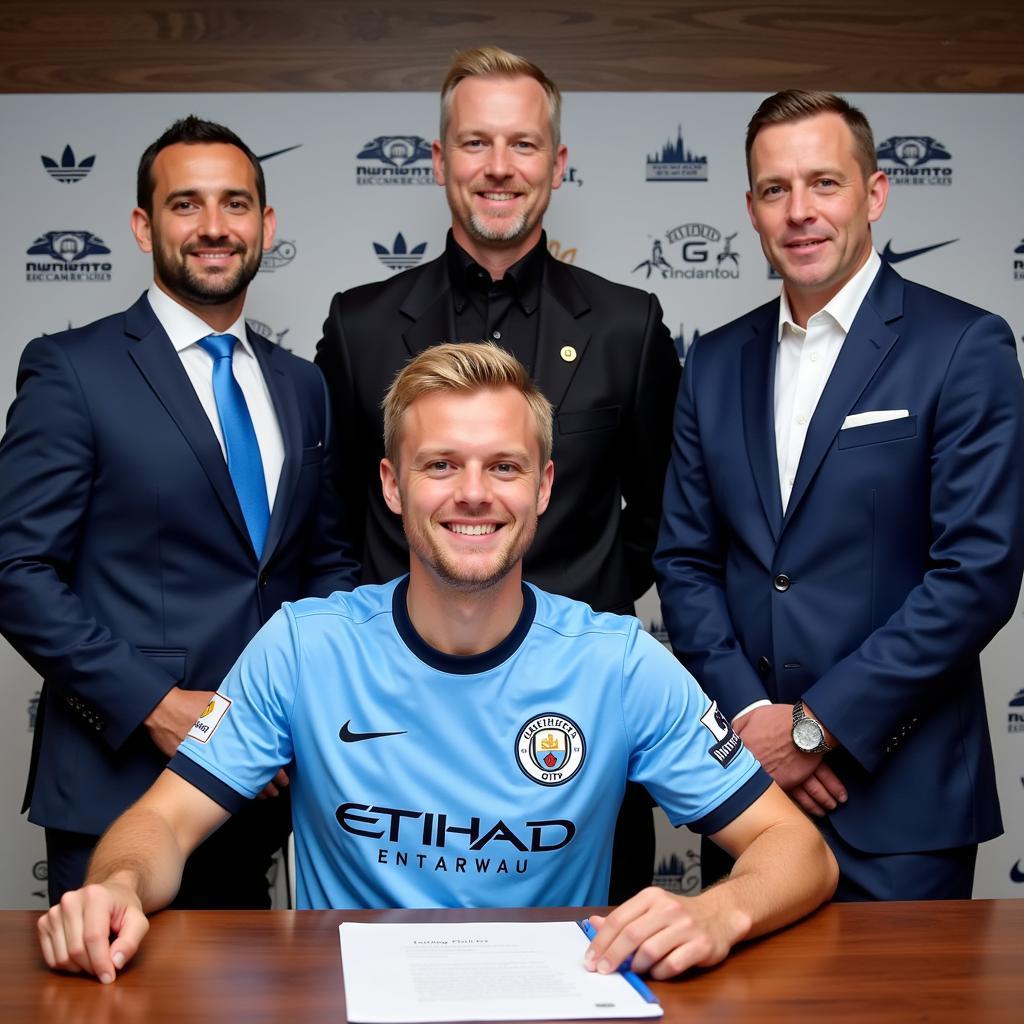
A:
381;386;553;592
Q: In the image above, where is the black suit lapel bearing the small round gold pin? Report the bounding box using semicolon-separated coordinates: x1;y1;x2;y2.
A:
534;254;590;413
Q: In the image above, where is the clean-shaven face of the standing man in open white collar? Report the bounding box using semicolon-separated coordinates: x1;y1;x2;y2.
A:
746;114;889;326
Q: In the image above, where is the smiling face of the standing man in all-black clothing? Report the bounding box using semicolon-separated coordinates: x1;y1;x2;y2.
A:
433;75;567;265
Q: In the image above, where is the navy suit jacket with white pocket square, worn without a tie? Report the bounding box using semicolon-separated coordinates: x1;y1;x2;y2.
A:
655;265;1024;853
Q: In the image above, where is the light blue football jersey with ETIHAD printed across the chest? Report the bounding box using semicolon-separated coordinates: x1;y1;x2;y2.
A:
171;577;770;908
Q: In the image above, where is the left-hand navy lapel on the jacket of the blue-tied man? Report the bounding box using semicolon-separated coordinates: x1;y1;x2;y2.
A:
125;295;252;550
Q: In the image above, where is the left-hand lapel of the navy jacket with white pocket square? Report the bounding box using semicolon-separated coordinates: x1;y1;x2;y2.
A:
739;302;782;540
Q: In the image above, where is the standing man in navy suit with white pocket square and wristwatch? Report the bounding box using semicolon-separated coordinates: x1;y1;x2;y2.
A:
655;90;1024;900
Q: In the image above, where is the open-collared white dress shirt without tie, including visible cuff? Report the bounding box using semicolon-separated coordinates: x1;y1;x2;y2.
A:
733;249;882;721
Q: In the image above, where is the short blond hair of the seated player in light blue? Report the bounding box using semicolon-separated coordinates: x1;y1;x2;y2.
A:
381;342;553;469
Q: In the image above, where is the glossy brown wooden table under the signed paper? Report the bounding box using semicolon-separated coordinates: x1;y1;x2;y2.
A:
0;900;1024;1024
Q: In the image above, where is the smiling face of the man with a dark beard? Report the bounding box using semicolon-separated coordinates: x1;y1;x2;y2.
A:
132;142;275;325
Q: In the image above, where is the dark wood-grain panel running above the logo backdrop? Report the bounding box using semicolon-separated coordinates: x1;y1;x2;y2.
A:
0;0;1024;92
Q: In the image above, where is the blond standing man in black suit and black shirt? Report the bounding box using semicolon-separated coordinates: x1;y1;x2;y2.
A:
316;47;679;902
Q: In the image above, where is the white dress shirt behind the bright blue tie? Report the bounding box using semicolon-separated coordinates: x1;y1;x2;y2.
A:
146;285;285;511
